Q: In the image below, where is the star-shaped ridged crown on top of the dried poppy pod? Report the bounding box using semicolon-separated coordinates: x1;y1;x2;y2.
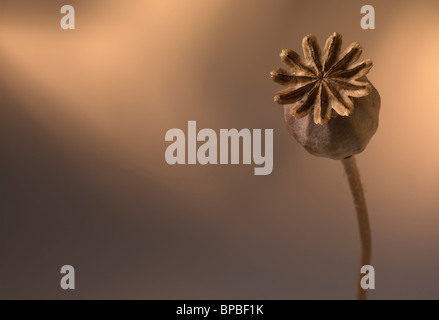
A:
271;33;372;124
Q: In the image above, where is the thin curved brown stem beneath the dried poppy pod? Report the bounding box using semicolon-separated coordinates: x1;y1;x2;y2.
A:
341;156;372;300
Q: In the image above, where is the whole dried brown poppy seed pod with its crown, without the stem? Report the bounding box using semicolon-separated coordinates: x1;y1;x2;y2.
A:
271;33;380;160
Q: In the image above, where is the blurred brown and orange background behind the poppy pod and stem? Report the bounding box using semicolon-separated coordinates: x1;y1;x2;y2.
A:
0;0;439;299
